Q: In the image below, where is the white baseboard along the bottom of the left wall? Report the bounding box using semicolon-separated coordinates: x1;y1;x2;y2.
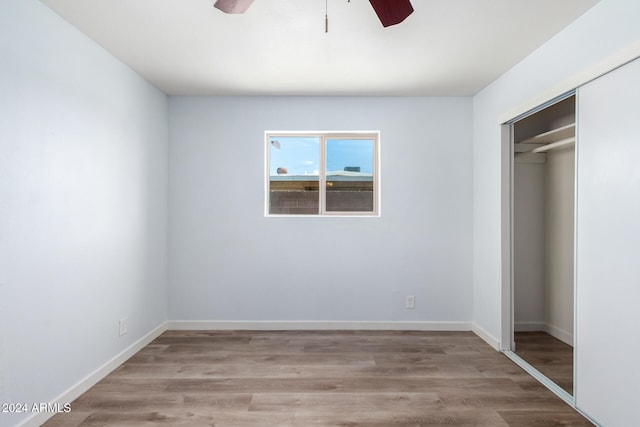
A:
19;322;167;427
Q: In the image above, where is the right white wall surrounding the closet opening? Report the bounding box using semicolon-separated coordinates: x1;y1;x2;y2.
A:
473;0;640;348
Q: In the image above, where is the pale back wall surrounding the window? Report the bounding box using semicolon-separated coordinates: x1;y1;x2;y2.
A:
169;97;472;325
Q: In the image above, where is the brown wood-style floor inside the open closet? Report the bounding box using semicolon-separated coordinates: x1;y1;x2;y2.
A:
514;332;573;394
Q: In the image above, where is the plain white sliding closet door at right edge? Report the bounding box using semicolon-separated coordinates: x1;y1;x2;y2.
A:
575;60;640;426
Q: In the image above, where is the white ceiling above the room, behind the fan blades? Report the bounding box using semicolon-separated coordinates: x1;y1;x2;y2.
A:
42;0;598;96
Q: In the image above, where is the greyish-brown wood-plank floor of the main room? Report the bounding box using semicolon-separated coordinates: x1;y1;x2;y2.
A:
45;331;591;427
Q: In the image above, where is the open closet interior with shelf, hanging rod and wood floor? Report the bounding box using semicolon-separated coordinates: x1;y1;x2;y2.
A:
512;93;576;395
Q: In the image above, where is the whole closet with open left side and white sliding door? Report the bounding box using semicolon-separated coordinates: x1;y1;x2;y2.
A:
500;58;640;426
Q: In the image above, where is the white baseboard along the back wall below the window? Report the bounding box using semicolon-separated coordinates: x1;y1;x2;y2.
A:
168;320;471;331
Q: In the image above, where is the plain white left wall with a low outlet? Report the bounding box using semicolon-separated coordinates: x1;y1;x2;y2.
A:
0;0;168;426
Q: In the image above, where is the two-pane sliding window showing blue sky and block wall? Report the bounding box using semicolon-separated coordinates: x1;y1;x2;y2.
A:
265;132;379;216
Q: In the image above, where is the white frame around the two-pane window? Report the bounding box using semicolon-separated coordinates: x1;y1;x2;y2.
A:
264;130;381;217
